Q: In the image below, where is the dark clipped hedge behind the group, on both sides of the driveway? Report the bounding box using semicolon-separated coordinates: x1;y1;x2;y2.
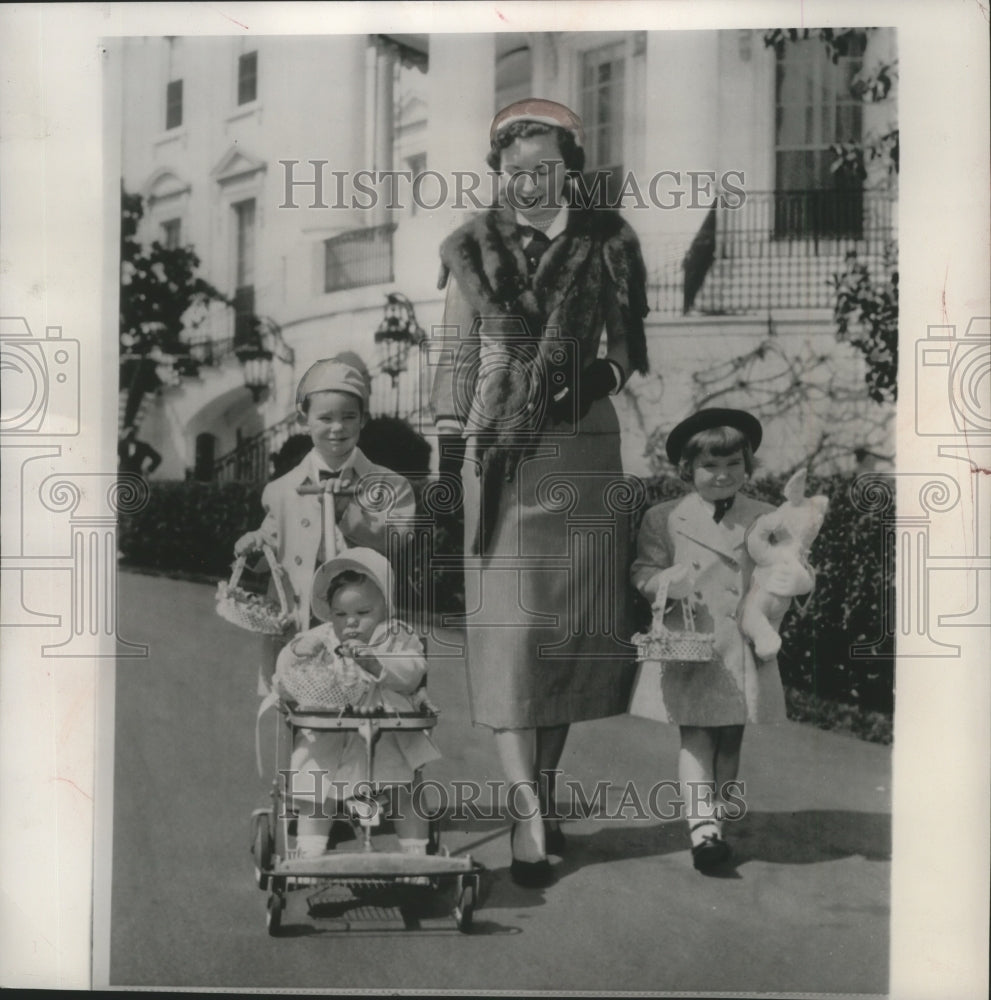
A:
118;468;894;714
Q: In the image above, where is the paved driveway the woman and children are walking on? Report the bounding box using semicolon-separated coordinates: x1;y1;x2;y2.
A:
110;574;891;994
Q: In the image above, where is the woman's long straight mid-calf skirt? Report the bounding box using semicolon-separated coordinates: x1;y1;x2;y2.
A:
463;399;642;729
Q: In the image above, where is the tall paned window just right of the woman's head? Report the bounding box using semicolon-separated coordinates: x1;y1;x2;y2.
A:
579;41;626;202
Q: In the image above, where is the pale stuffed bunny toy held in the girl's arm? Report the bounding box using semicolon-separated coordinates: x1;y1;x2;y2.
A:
740;469;829;660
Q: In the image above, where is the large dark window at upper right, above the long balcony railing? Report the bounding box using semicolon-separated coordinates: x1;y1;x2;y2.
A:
775;33;863;236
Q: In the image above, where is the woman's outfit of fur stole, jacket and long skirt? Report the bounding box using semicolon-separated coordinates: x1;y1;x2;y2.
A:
433;210;646;729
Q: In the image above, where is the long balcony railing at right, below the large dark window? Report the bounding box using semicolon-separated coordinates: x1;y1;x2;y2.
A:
647;191;895;315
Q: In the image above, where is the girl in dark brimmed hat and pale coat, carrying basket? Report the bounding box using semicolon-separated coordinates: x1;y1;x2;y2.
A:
633;409;785;871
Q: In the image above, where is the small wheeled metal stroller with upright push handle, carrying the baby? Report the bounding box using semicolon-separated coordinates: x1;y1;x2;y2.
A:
251;481;482;935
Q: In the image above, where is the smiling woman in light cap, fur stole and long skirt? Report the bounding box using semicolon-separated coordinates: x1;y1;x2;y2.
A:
432;98;647;886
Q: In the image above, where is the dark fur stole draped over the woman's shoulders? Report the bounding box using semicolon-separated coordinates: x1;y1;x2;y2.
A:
438;198;648;551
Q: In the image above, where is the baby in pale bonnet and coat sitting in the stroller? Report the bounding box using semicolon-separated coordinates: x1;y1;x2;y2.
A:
273;548;440;857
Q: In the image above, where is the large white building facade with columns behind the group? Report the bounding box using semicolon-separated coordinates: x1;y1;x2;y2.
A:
120;30;896;478
